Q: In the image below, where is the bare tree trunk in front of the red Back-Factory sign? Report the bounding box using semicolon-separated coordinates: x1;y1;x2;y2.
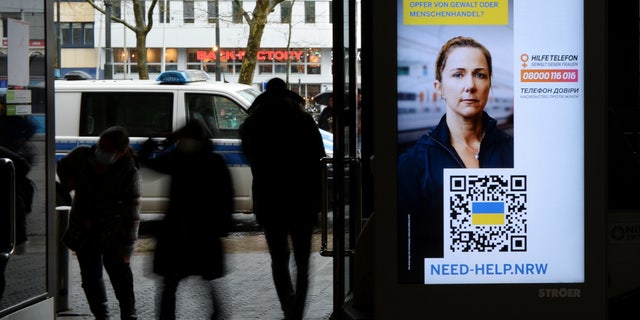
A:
233;0;285;85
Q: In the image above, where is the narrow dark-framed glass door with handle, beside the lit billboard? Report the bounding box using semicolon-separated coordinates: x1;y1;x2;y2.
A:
321;0;370;319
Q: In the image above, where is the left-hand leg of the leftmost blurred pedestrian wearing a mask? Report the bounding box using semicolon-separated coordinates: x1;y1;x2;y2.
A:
76;247;109;320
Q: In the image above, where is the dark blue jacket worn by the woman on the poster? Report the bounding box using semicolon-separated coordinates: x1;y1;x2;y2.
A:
398;112;513;283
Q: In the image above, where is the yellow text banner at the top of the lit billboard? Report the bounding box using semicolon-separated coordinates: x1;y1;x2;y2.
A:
402;0;509;25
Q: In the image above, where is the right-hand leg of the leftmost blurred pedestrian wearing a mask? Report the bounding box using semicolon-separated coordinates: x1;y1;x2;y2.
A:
104;250;138;320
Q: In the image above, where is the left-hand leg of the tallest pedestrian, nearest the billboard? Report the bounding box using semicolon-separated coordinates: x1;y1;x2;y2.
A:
264;224;295;315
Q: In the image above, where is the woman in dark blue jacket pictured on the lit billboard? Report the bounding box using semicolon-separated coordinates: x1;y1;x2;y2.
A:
397;36;514;283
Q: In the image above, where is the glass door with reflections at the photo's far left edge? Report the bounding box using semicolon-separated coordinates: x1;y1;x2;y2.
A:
0;0;55;319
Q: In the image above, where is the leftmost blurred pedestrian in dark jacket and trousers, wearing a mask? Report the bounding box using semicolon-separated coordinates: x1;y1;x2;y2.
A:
57;126;141;320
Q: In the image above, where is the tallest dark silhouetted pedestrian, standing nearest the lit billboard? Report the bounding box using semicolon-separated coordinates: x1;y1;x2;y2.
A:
240;78;325;319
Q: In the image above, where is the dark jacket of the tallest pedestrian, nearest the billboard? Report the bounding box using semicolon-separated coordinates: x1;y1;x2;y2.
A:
240;91;325;226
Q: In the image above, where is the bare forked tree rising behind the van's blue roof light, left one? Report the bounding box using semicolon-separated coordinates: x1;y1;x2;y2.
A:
86;0;158;80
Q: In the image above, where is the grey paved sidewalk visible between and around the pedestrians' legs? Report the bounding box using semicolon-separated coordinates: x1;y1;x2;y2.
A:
56;233;333;320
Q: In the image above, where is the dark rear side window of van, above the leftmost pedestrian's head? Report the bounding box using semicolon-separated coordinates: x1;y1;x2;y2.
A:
80;92;173;137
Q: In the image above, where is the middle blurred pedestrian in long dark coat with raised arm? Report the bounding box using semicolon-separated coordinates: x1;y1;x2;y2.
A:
138;121;233;320
